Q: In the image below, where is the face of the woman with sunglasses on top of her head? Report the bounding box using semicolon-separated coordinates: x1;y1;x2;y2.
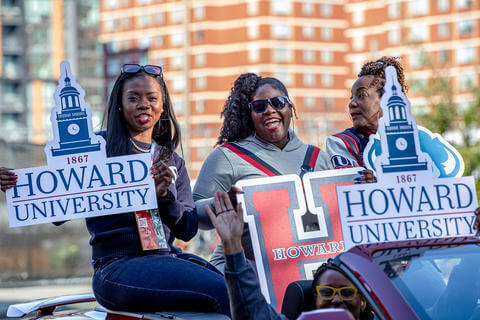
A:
122;75;163;143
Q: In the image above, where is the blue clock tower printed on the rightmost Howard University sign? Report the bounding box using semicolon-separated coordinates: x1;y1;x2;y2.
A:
382;84;427;172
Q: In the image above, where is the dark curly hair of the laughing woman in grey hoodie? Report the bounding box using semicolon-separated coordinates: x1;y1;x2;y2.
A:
216;73;297;145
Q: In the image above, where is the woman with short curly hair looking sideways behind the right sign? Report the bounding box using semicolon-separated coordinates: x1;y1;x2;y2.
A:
326;56;408;176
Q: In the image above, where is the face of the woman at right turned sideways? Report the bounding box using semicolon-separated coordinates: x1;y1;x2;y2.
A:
348;76;382;132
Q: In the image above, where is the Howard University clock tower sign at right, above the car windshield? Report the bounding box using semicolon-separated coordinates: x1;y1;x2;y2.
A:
337;67;477;249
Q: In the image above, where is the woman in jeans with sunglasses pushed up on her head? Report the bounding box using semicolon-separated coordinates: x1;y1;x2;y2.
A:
0;64;230;315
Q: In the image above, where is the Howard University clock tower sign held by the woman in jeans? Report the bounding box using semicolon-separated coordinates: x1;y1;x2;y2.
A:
6;61;157;227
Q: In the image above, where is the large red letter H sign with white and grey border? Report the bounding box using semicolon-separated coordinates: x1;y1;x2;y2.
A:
237;168;358;310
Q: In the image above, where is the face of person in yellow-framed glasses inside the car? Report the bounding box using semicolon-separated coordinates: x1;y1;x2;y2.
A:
315;269;367;319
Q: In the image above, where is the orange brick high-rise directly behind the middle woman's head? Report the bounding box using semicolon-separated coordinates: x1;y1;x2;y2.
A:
100;0;351;177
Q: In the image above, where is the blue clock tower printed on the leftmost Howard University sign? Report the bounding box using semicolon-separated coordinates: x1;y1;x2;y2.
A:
51;70;100;157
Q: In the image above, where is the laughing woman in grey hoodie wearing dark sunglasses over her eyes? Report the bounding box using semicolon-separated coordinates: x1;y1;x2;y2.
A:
193;73;332;271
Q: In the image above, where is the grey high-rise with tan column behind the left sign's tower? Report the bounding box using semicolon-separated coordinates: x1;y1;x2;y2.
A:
0;0;105;144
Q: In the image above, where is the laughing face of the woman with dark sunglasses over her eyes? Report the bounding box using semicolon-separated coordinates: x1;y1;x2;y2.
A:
251;84;292;149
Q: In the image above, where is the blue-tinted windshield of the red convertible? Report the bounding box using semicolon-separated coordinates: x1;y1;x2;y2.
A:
373;244;480;320
